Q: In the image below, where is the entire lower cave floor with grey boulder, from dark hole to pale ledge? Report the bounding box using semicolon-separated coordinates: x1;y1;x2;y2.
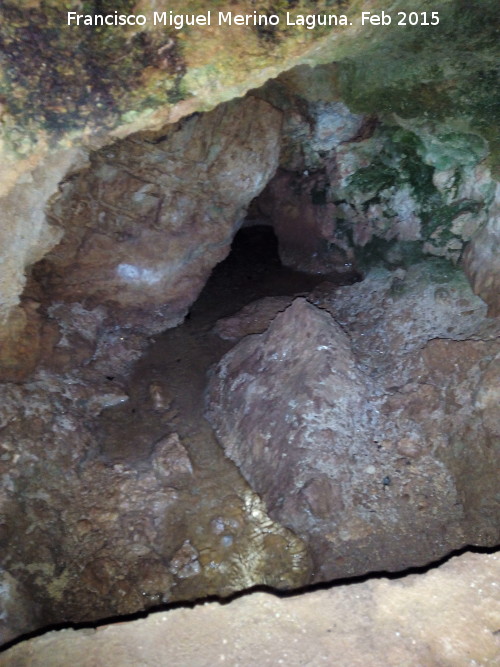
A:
0;219;500;642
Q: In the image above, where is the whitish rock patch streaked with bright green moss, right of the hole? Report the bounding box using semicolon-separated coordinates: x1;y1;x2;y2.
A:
327;125;496;267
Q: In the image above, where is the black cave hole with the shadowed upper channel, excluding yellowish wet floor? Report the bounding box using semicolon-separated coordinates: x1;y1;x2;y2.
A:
93;225;356;465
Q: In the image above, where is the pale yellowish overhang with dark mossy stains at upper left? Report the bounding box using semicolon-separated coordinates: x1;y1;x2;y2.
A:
0;0;362;340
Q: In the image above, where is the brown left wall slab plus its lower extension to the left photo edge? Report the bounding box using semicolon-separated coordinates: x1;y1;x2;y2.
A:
0;97;282;382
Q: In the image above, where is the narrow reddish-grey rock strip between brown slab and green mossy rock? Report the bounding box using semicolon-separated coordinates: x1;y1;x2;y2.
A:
248;86;366;273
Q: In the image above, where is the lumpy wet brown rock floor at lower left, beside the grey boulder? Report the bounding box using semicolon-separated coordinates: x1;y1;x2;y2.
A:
0;366;310;644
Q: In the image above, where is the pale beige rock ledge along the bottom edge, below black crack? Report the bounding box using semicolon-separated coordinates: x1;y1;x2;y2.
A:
2;553;500;667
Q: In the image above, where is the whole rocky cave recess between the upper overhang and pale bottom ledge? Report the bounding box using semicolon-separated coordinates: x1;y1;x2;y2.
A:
0;57;500;652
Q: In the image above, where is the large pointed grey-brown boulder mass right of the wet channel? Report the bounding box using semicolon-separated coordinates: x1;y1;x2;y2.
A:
208;263;500;580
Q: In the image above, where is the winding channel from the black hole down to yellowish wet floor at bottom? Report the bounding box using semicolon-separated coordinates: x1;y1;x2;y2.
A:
93;226;354;601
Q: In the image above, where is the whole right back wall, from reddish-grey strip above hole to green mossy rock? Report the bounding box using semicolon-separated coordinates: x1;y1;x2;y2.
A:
251;64;498;304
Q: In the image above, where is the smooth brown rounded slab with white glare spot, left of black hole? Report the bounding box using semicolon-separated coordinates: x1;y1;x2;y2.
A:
31;97;281;331
